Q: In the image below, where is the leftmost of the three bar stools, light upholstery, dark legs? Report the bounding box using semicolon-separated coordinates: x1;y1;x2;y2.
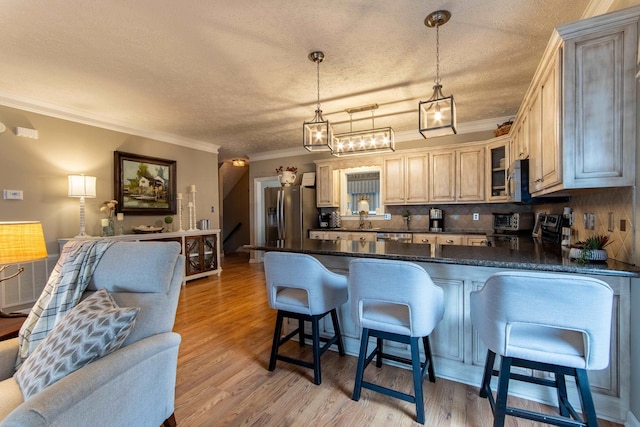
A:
264;252;348;384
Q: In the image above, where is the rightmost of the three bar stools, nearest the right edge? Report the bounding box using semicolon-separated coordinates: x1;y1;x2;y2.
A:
471;272;613;427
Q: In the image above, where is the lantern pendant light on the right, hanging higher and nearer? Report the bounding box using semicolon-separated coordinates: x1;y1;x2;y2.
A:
418;10;457;138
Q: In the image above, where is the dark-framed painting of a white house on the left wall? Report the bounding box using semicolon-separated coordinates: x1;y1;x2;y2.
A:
114;151;176;215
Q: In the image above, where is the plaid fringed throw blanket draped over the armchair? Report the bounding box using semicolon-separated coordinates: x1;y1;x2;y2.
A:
16;240;115;370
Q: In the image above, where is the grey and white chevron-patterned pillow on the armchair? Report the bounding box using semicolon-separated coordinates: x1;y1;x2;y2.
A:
15;289;139;400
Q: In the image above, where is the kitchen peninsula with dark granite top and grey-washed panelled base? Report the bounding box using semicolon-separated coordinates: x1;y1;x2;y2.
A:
246;237;640;422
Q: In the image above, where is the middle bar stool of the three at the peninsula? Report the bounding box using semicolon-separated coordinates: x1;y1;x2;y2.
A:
349;259;444;424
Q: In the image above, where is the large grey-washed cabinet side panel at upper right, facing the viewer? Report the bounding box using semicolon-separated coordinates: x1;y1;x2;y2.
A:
563;23;638;188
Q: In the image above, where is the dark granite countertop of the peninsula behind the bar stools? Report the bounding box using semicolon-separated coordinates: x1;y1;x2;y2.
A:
245;237;640;277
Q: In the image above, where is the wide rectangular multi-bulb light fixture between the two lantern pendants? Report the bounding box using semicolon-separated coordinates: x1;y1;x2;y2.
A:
333;104;396;157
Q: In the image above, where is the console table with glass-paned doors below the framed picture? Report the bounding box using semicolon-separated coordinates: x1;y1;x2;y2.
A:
58;229;222;282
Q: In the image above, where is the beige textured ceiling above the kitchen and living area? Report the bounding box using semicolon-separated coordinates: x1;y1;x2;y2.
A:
0;0;589;161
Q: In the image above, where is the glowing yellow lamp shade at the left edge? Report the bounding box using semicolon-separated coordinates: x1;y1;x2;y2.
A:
0;221;47;265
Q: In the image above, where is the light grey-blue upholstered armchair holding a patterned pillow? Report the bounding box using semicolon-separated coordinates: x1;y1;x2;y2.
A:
0;242;185;427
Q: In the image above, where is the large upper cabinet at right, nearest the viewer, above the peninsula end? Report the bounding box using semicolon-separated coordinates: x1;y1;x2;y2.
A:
511;7;640;195
